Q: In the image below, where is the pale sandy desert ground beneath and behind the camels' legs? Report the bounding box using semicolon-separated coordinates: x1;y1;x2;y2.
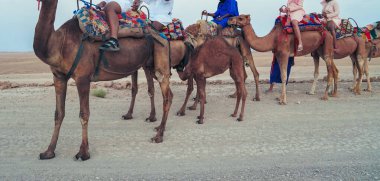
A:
0;53;380;180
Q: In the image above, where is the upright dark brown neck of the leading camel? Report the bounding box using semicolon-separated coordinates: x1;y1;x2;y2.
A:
33;0;58;65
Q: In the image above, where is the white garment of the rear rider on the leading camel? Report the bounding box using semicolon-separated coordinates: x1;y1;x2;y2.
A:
142;0;174;25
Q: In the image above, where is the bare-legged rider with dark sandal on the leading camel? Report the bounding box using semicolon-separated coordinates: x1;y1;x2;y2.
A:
98;0;140;51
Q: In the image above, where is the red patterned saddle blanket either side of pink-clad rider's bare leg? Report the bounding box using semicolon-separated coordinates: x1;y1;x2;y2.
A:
275;13;323;34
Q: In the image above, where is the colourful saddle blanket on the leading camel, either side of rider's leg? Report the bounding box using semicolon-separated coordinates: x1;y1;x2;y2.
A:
76;7;149;40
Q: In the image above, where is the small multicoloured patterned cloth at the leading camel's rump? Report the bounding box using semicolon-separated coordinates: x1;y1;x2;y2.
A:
162;18;186;41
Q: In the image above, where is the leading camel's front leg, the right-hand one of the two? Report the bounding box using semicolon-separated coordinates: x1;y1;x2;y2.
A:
75;78;90;161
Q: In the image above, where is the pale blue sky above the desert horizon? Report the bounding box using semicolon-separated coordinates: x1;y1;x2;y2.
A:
0;0;380;52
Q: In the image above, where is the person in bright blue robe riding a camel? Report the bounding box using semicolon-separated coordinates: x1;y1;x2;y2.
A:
202;0;239;32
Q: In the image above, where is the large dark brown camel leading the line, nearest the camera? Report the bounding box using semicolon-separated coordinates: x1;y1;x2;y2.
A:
33;0;172;160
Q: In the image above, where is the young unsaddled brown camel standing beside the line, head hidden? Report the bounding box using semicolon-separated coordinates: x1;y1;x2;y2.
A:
179;37;247;124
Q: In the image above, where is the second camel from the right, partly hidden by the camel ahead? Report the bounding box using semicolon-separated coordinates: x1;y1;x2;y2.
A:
308;35;367;96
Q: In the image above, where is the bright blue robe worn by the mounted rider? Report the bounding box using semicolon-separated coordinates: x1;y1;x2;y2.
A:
212;0;239;28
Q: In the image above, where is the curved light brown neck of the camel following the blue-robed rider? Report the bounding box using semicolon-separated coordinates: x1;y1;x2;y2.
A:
242;24;275;52
